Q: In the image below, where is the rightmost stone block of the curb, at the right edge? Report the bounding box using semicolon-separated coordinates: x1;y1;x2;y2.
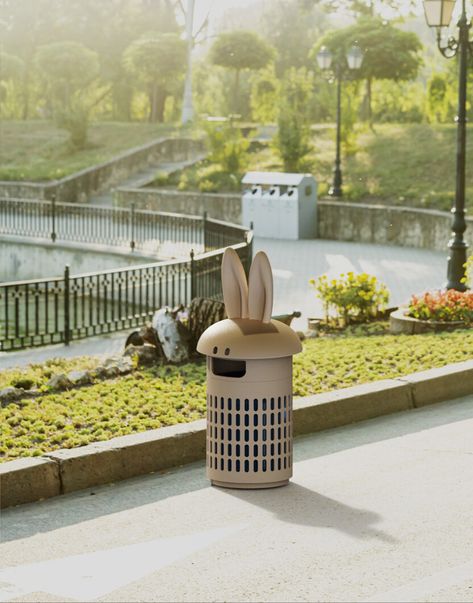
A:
398;360;473;408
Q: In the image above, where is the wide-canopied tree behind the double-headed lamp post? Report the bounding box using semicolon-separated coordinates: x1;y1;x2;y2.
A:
312;17;422;123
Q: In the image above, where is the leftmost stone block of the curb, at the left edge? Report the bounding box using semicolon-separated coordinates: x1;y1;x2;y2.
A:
0;457;61;508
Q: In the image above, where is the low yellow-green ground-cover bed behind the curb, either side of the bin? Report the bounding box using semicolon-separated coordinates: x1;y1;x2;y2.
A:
0;330;473;461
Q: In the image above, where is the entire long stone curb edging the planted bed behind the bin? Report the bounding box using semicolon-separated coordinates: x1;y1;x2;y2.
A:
0;359;473;508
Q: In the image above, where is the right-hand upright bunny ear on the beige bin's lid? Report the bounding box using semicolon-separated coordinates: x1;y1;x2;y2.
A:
248;251;273;322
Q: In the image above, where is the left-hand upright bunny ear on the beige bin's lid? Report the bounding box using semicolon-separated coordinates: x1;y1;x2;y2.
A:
222;247;248;318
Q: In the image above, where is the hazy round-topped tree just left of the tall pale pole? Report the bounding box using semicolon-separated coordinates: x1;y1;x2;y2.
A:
123;32;187;122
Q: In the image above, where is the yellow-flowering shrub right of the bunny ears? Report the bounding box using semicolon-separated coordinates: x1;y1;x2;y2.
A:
309;272;389;325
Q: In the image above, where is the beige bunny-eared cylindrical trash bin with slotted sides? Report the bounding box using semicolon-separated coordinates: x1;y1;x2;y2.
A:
197;248;302;488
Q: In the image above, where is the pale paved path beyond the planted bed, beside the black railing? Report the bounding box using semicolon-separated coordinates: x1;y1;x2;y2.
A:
0;238;446;369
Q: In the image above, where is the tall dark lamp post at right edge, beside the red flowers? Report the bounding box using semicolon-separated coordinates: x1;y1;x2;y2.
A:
424;0;473;291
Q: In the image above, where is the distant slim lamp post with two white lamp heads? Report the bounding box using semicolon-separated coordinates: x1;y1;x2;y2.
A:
317;46;363;197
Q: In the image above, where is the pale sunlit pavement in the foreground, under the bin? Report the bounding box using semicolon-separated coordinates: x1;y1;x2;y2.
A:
0;397;473;602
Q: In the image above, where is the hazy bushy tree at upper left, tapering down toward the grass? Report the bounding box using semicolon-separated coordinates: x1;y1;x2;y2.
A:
35;42;99;148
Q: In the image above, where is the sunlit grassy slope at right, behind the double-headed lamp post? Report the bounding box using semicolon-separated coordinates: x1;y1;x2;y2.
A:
153;124;473;210
